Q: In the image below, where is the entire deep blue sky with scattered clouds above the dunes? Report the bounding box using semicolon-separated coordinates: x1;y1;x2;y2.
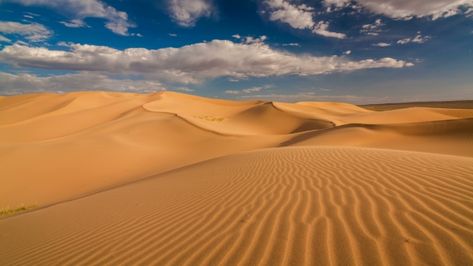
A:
0;0;473;103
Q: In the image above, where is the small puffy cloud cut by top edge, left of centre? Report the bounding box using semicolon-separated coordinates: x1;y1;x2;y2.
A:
169;0;215;27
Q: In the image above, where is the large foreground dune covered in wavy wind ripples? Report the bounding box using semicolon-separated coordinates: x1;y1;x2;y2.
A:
0;146;473;265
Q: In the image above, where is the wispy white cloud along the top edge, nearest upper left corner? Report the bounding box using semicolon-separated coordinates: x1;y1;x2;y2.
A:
4;0;134;36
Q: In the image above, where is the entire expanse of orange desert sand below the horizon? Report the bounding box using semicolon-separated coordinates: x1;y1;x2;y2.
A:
0;92;473;265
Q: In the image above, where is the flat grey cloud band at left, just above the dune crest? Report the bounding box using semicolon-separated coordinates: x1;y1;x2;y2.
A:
0;72;164;94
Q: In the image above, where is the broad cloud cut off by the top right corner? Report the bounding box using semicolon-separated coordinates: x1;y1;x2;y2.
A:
324;0;473;19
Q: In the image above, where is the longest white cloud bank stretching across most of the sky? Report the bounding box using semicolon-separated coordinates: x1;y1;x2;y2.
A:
0;40;413;83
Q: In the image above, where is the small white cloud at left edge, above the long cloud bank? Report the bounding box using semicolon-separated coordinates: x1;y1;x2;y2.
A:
0;21;52;42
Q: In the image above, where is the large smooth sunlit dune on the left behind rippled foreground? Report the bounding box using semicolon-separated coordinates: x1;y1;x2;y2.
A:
0;93;279;208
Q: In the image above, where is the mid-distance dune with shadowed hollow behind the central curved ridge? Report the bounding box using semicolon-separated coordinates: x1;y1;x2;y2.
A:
142;98;335;136
